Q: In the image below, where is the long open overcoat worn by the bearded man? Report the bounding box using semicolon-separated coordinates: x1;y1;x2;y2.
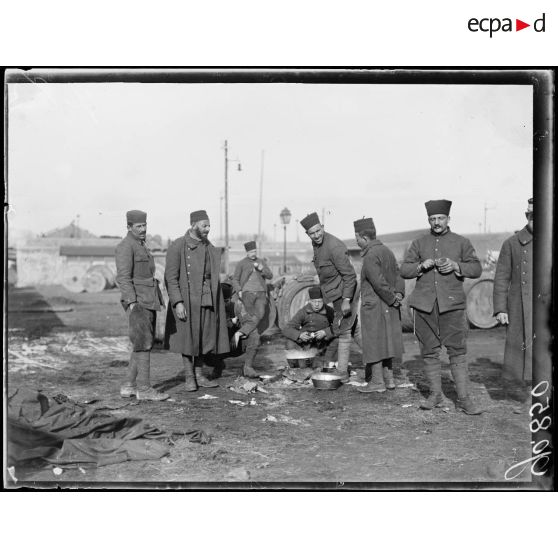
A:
165;231;230;355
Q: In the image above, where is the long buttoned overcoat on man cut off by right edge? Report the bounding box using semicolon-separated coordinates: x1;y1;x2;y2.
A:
494;227;533;380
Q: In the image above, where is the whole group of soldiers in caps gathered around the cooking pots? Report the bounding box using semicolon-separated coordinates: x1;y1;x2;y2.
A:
116;199;533;415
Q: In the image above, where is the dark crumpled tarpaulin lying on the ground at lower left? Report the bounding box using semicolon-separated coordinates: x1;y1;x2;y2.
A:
8;388;210;466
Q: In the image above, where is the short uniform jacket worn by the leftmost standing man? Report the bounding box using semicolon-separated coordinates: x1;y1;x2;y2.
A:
116;232;164;311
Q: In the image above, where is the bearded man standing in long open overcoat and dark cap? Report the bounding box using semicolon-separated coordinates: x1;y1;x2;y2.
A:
165;210;230;391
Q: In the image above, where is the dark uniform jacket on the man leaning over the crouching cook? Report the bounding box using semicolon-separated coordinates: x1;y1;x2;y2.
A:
312;232;357;303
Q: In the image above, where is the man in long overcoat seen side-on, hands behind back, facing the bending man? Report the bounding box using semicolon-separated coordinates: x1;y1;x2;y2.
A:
354;218;405;393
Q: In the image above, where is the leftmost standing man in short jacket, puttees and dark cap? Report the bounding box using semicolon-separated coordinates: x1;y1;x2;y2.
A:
116;210;169;401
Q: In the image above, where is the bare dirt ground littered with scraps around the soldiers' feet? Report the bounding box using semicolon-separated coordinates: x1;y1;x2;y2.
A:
7;287;531;488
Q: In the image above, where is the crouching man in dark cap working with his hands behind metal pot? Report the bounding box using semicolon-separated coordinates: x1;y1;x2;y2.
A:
282;285;339;372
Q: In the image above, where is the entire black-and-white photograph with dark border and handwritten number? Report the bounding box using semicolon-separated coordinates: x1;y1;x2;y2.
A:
3;68;554;490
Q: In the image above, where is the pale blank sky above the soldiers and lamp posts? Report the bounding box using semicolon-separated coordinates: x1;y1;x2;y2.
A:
8;83;532;240
